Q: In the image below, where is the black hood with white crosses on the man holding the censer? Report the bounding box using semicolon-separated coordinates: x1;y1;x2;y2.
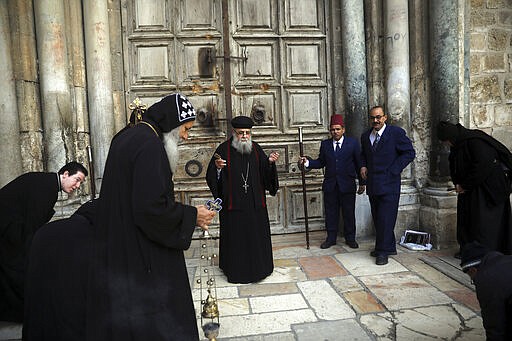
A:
143;93;196;133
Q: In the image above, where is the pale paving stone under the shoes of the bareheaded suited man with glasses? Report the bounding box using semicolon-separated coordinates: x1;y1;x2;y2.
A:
335;251;407;277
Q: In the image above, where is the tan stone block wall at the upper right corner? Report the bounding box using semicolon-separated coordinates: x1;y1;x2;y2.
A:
469;0;512;148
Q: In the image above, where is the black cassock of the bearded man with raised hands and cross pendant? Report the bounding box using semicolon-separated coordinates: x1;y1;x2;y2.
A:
206;138;279;283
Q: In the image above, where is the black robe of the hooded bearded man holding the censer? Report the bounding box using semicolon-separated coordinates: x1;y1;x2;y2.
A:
86;124;199;341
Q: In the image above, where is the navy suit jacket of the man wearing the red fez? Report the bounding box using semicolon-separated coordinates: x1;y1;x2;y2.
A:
308;136;364;193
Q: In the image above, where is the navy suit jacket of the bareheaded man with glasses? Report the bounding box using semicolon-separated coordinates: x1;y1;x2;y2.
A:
361;125;416;195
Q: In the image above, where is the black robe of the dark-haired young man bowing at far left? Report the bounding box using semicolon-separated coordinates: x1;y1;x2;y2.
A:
0;172;59;322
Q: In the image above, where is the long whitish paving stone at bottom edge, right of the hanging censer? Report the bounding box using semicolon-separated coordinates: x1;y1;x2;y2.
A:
215;309;318;339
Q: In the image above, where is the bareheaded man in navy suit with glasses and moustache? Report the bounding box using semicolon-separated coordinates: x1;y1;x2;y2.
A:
361;106;416;265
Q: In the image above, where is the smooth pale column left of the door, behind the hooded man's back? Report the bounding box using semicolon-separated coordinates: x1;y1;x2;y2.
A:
83;0;114;191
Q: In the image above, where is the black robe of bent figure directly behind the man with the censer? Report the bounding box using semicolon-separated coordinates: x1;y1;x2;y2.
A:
23;200;95;341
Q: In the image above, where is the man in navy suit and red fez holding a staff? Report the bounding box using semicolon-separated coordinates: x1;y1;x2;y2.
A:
300;115;364;249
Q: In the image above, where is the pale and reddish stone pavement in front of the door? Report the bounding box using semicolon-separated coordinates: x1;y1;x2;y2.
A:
0;232;485;341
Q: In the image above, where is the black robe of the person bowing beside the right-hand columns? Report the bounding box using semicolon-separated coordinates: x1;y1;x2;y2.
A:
449;135;512;254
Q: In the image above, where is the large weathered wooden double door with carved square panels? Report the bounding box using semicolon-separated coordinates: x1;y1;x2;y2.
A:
122;0;332;233
